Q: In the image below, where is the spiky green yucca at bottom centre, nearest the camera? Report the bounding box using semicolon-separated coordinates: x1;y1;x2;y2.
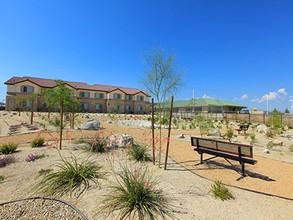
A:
101;167;173;220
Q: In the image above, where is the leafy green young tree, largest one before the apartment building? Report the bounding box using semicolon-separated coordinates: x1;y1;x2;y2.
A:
43;80;76;150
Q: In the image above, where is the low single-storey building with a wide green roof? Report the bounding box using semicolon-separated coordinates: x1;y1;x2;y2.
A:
155;98;246;113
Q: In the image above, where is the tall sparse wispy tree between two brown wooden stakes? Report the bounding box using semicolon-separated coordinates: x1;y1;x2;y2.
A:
141;47;183;167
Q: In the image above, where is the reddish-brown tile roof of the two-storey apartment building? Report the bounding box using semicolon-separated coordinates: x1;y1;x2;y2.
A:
4;76;149;96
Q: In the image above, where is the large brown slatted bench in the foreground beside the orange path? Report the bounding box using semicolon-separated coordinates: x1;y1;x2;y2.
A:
191;137;257;176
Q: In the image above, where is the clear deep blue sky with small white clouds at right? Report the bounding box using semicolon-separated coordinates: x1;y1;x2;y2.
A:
0;0;293;111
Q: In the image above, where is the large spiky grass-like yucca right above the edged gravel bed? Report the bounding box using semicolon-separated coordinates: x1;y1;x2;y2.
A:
33;156;105;198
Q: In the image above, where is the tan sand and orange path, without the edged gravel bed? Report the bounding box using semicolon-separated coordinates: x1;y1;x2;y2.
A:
0;112;293;219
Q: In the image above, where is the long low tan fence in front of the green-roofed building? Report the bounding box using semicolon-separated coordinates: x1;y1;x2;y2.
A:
159;111;293;127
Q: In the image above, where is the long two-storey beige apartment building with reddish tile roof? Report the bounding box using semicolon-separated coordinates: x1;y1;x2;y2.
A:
4;76;150;114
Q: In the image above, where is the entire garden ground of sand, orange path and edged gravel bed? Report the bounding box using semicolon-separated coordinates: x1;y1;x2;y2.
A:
0;111;293;220
